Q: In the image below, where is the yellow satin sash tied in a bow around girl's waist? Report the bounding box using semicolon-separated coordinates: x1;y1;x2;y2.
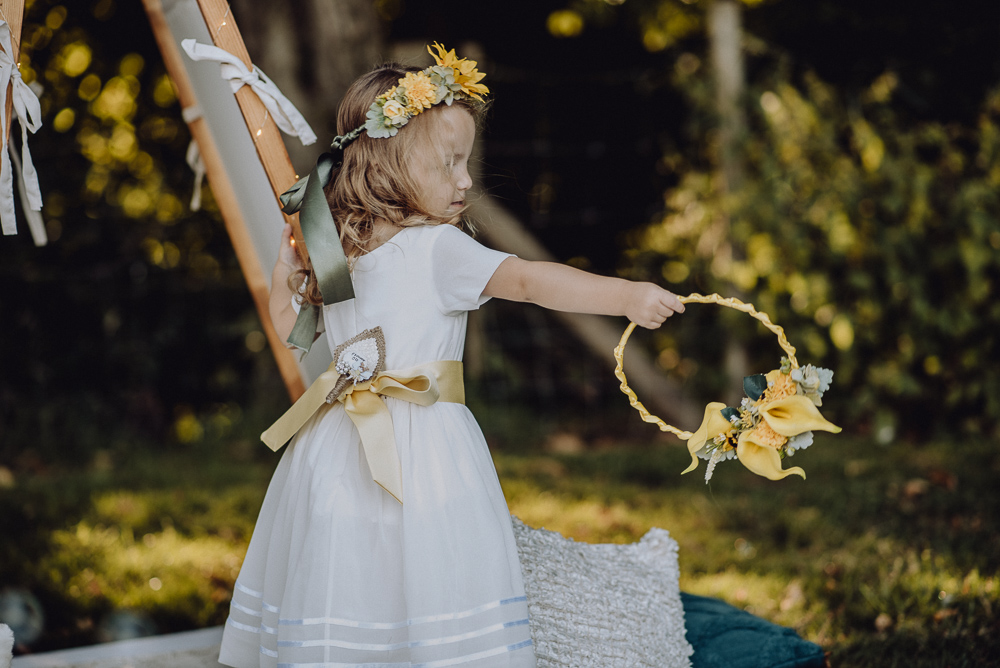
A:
260;360;465;503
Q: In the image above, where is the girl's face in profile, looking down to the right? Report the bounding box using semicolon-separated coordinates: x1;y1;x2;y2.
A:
411;105;476;216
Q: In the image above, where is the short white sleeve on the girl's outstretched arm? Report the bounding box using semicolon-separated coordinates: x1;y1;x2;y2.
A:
431;225;512;314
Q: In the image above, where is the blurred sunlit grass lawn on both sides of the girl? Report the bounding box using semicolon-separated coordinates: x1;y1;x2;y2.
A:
0;436;1000;668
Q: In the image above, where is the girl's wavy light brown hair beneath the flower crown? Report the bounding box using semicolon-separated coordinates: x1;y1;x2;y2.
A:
288;63;483;305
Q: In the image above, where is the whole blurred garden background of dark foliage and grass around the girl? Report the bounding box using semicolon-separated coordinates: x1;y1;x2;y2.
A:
0;0;1000;665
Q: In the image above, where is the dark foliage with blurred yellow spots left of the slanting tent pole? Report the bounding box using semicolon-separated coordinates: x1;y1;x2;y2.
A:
0;0;273;461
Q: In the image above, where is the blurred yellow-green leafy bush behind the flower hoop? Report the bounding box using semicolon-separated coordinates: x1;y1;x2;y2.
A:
633;53;1000;440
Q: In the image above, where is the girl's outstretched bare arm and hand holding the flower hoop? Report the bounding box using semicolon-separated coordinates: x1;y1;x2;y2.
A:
483;257;684;329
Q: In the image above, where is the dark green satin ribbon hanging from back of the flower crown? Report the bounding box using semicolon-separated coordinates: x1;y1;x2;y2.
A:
280;153;354;353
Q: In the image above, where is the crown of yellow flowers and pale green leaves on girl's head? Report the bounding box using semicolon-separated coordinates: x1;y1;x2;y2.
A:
360;42;490;139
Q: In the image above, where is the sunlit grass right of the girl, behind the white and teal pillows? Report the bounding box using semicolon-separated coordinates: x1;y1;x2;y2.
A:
497;437;1000;666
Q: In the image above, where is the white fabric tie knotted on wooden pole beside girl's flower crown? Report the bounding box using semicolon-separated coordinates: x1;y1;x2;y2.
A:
181;39;316;146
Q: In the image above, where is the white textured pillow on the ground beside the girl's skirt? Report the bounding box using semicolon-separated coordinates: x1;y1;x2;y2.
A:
512;517;694;668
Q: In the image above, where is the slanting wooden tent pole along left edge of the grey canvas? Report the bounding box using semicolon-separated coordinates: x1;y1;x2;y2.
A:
143;0;305;401
